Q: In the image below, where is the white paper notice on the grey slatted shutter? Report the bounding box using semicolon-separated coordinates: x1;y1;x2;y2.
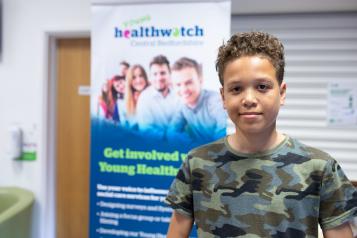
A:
327;80;357;127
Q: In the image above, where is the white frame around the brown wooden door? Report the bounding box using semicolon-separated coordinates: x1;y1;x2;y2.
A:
44;31;90;238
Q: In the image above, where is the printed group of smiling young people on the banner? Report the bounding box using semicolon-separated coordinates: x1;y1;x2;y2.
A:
98;55;227;144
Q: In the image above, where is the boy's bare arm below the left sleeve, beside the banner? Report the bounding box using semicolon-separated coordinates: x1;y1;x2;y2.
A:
166;211;193;238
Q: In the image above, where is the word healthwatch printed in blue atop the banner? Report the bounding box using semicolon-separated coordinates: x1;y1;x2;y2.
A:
114;26;204;39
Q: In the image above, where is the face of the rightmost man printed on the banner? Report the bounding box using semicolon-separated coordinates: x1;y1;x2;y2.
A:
171;67;202;107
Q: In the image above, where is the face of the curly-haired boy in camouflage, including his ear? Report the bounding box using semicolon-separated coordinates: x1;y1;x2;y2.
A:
221;56;286;135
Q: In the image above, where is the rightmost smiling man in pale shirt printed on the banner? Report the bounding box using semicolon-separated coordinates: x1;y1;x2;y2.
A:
168;57;227;145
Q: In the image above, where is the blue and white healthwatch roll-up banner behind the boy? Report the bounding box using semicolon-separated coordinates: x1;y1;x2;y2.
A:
90;1;231;238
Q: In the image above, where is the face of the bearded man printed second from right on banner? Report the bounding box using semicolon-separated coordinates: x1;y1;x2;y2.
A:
150;64;170;92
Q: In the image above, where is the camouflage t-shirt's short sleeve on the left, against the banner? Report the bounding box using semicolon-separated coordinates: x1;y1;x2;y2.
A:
165;155;193;217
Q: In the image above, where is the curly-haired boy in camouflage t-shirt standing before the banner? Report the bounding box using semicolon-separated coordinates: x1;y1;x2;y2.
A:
166;32;357;238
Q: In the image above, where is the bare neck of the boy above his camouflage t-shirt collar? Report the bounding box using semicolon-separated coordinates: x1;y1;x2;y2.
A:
228;129;285;153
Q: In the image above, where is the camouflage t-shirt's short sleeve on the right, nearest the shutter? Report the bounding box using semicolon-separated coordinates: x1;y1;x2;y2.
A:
319;159;357;229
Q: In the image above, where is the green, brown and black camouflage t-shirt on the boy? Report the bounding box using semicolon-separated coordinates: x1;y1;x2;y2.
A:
166;137;357;238
